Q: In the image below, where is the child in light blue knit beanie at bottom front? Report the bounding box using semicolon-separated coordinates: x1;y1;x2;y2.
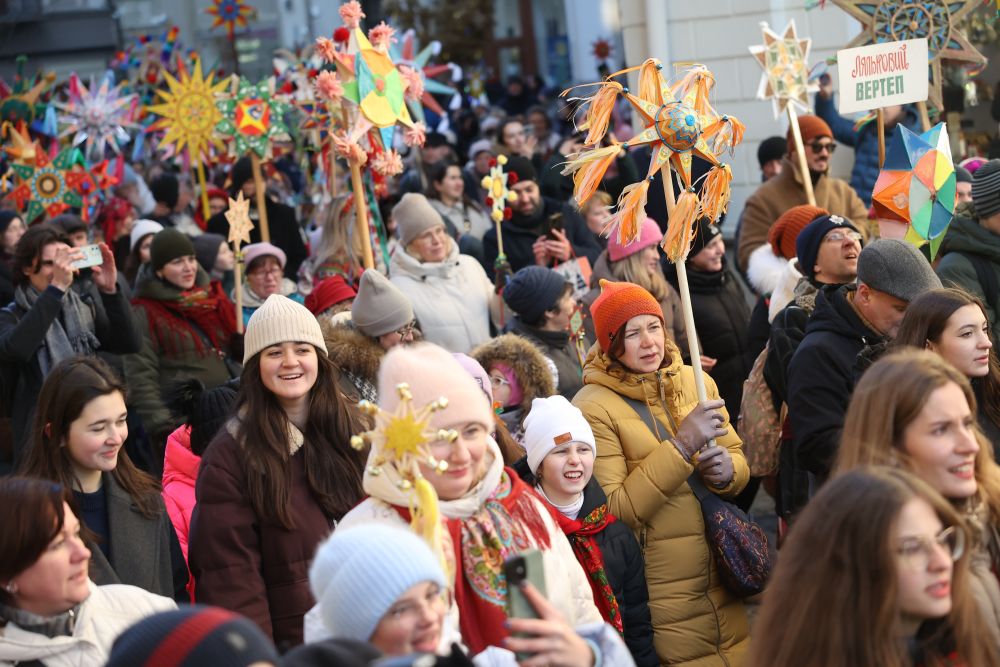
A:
309;524;447;656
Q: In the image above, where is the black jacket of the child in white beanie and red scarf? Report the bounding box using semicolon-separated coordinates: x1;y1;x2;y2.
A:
513;457;659;667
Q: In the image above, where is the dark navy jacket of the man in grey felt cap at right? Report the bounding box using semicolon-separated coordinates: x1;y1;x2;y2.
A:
779;285;884;515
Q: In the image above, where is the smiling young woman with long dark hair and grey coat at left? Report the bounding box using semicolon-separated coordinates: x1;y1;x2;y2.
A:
21;357;189;601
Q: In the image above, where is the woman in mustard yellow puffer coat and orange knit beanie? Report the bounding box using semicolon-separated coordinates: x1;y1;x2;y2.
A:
573;280;750;667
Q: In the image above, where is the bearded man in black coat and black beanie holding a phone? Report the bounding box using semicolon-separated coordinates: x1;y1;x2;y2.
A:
483;156;603;277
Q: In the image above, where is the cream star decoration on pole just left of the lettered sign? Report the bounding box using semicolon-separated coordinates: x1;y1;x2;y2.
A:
750;20;819;118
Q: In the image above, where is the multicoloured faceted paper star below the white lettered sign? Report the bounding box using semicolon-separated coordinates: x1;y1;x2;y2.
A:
872;123;955;259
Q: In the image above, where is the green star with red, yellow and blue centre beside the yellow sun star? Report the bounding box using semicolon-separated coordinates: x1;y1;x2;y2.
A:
215;77;289;158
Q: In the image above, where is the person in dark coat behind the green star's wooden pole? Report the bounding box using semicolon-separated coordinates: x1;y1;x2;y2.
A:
205;157;308;280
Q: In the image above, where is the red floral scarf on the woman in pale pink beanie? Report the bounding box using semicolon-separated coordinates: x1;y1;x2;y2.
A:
393;468;551;655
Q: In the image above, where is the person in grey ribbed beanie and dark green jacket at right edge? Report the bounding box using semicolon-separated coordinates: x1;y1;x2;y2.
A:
937;160;1000;342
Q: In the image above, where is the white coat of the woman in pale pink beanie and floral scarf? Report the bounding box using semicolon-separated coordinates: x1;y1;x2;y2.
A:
305;438;603;653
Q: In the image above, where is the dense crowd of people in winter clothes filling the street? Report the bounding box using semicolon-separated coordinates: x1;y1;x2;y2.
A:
0;65;1000;667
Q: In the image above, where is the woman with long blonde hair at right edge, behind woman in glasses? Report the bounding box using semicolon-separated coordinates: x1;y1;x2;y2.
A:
834;349;1000;652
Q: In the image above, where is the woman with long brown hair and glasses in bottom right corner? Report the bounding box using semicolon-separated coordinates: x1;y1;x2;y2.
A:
749;467;1000;667
